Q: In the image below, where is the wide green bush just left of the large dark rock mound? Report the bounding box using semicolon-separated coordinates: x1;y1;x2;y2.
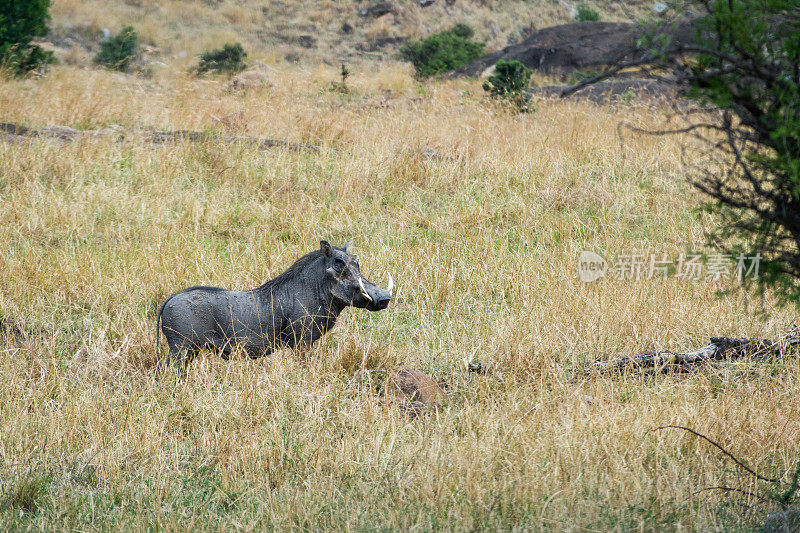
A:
400;24;486;78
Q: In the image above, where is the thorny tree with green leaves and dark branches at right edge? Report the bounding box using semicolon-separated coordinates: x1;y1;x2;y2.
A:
591;0;800;306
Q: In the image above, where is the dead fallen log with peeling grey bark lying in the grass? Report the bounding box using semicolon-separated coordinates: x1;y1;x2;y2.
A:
583;336;800;375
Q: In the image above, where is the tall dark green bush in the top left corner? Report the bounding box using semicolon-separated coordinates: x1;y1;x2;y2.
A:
0;0;53;75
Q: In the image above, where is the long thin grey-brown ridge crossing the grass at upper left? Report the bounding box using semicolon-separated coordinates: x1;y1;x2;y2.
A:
0;122;324;152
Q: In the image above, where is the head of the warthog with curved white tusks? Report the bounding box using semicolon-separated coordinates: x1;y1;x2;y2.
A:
320;241;394;311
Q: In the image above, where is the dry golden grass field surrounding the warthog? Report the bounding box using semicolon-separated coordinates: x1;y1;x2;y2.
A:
0;53;800;531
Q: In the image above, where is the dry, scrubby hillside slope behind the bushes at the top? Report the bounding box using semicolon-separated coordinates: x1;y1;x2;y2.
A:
50;0;651;64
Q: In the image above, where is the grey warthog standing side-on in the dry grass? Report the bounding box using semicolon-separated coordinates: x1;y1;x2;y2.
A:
156;241;393;368
